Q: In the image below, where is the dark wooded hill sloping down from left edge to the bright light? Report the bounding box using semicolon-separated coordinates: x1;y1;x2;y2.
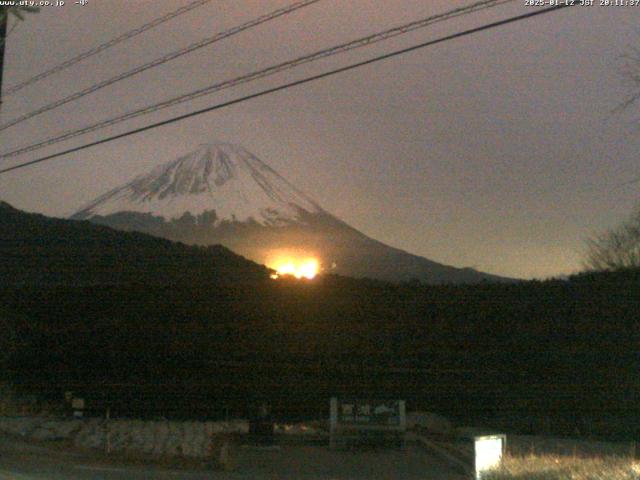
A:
0;202;269;286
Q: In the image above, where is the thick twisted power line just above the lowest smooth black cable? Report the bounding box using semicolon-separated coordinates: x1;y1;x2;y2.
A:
0;0;514;159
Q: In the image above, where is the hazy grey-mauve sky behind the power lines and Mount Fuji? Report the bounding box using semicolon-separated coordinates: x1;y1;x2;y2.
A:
0;0;640;278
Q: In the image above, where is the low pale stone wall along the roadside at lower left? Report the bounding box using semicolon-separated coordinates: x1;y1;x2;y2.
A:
0;417;249;458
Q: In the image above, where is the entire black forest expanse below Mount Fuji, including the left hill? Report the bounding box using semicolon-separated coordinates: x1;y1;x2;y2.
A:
0;201;640;438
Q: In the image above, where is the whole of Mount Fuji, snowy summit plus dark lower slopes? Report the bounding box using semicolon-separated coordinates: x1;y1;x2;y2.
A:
71;143;507;284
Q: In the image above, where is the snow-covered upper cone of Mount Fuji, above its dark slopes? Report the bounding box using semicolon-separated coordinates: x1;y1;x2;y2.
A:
74;142;323;225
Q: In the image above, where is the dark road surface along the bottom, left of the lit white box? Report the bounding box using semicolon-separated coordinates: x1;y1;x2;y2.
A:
0;436;465;480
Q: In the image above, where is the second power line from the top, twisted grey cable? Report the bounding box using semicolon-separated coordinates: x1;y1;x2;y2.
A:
0;0;320;132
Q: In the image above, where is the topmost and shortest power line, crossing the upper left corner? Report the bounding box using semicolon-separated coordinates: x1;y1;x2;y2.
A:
3;0;211;96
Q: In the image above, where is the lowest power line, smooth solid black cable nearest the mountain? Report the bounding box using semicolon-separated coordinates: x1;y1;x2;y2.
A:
0;4;572;174
